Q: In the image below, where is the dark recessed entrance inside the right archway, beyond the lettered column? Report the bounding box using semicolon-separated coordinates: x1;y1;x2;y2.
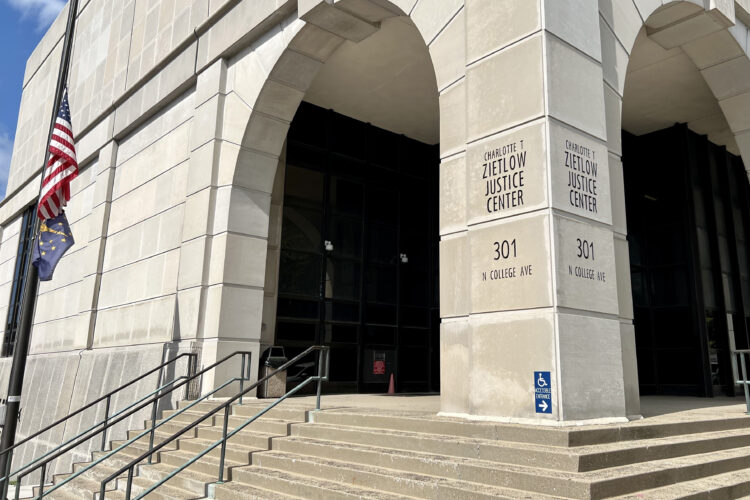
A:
623;125;750;396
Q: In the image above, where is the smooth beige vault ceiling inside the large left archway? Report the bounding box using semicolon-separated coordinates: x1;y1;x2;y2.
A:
305;17;440;144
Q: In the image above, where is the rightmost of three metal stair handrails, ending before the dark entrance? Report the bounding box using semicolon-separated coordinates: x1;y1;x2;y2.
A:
99;345;330;500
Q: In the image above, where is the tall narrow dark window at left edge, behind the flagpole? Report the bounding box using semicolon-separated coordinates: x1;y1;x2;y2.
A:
2;206;34;357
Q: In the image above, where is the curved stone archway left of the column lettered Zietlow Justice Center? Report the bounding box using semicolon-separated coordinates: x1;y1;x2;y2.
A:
206;0;465;390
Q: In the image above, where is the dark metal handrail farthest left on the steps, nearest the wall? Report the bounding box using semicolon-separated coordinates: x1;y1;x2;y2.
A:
0;352;198;492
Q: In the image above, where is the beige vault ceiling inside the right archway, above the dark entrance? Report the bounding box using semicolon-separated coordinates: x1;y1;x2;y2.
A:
622;30;739;155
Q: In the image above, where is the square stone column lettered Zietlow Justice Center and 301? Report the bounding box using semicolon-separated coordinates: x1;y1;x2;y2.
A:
440;0;629;421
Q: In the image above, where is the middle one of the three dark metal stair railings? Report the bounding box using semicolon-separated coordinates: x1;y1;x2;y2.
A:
8;351;251;500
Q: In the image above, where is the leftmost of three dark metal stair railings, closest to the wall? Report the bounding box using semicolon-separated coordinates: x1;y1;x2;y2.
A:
0;352;198;498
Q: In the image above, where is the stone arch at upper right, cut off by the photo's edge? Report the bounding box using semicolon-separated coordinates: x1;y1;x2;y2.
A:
599;0;750;168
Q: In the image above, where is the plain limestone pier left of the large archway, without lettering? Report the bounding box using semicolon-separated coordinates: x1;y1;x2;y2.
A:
175;59;265;395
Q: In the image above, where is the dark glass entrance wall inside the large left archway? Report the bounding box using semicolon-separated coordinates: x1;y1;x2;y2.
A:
276;104;439;392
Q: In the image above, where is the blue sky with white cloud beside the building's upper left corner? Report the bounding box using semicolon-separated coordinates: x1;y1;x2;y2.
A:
0;0;66;198
